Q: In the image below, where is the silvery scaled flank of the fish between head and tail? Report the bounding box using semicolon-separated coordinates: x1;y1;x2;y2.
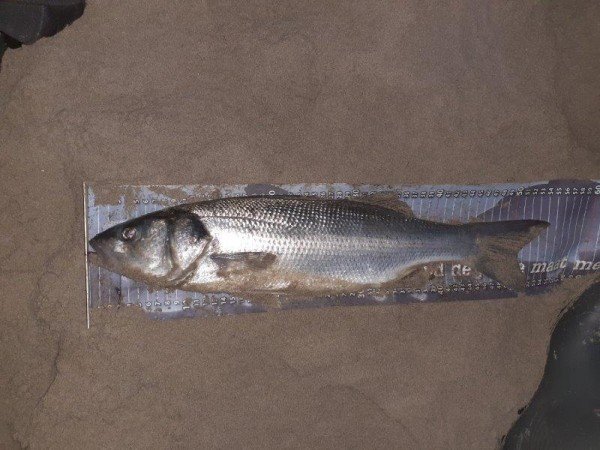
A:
182;197;471;284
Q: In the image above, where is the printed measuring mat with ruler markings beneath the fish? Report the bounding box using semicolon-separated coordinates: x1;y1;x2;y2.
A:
84;180;600;326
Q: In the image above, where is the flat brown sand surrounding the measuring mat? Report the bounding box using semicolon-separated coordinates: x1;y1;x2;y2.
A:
0;0;600;449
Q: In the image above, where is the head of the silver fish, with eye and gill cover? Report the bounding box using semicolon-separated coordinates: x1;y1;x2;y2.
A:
90;209;210;286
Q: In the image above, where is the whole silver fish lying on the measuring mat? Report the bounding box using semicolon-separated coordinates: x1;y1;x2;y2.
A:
90;194;549;303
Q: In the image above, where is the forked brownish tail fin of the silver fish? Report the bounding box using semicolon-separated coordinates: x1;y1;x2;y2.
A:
463;220;550;291
